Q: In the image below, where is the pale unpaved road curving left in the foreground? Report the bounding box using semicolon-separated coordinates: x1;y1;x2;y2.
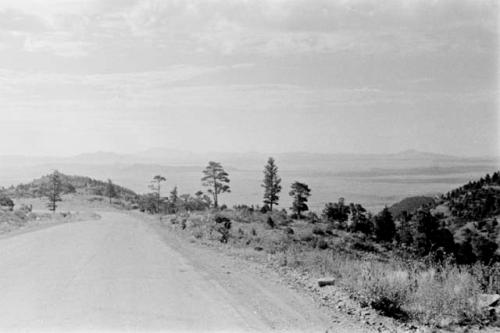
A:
0;213;370;332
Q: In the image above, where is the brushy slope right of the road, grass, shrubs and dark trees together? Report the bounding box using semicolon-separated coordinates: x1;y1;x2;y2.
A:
157;171;500;326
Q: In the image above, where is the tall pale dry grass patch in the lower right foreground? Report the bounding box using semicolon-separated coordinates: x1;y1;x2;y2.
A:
280;247;485;325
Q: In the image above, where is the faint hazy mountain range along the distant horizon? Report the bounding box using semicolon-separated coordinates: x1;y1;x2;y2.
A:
0;148;492;171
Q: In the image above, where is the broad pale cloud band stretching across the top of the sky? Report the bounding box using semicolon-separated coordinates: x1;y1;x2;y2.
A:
0;0;498;57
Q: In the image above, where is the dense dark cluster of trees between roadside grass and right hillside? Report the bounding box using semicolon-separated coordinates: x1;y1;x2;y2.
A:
322;198;500;264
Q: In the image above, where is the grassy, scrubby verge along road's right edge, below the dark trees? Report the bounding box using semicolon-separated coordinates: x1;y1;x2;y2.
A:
163;211;500;329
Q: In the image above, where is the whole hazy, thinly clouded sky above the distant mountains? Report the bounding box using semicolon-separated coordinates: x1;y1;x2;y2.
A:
0;0;500;155
